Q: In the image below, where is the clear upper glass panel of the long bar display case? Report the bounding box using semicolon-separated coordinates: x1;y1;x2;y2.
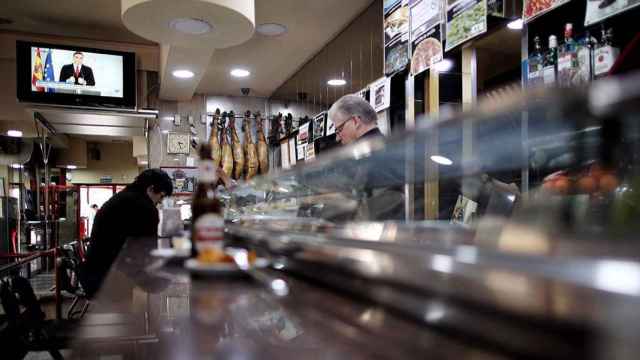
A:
226;72;640;253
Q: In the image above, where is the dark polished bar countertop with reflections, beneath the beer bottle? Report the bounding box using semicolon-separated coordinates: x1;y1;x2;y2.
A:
72;239;509;359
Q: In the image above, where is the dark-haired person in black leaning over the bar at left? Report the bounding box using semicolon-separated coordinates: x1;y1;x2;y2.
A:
79;169;173;296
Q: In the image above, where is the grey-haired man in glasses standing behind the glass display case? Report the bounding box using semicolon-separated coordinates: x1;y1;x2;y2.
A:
329;95;404;221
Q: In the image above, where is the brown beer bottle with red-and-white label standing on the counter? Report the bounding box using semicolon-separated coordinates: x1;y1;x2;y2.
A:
191;144;224;261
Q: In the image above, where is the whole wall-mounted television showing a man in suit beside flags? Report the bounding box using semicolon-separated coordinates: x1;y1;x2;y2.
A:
16;41;136;109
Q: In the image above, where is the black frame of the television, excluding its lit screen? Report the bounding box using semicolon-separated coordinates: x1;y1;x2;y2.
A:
16;41;136;109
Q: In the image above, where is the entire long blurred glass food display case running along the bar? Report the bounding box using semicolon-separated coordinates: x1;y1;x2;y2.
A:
225;71;640;358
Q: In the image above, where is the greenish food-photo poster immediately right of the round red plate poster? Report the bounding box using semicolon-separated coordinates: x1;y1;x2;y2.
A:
445;0;487;51
